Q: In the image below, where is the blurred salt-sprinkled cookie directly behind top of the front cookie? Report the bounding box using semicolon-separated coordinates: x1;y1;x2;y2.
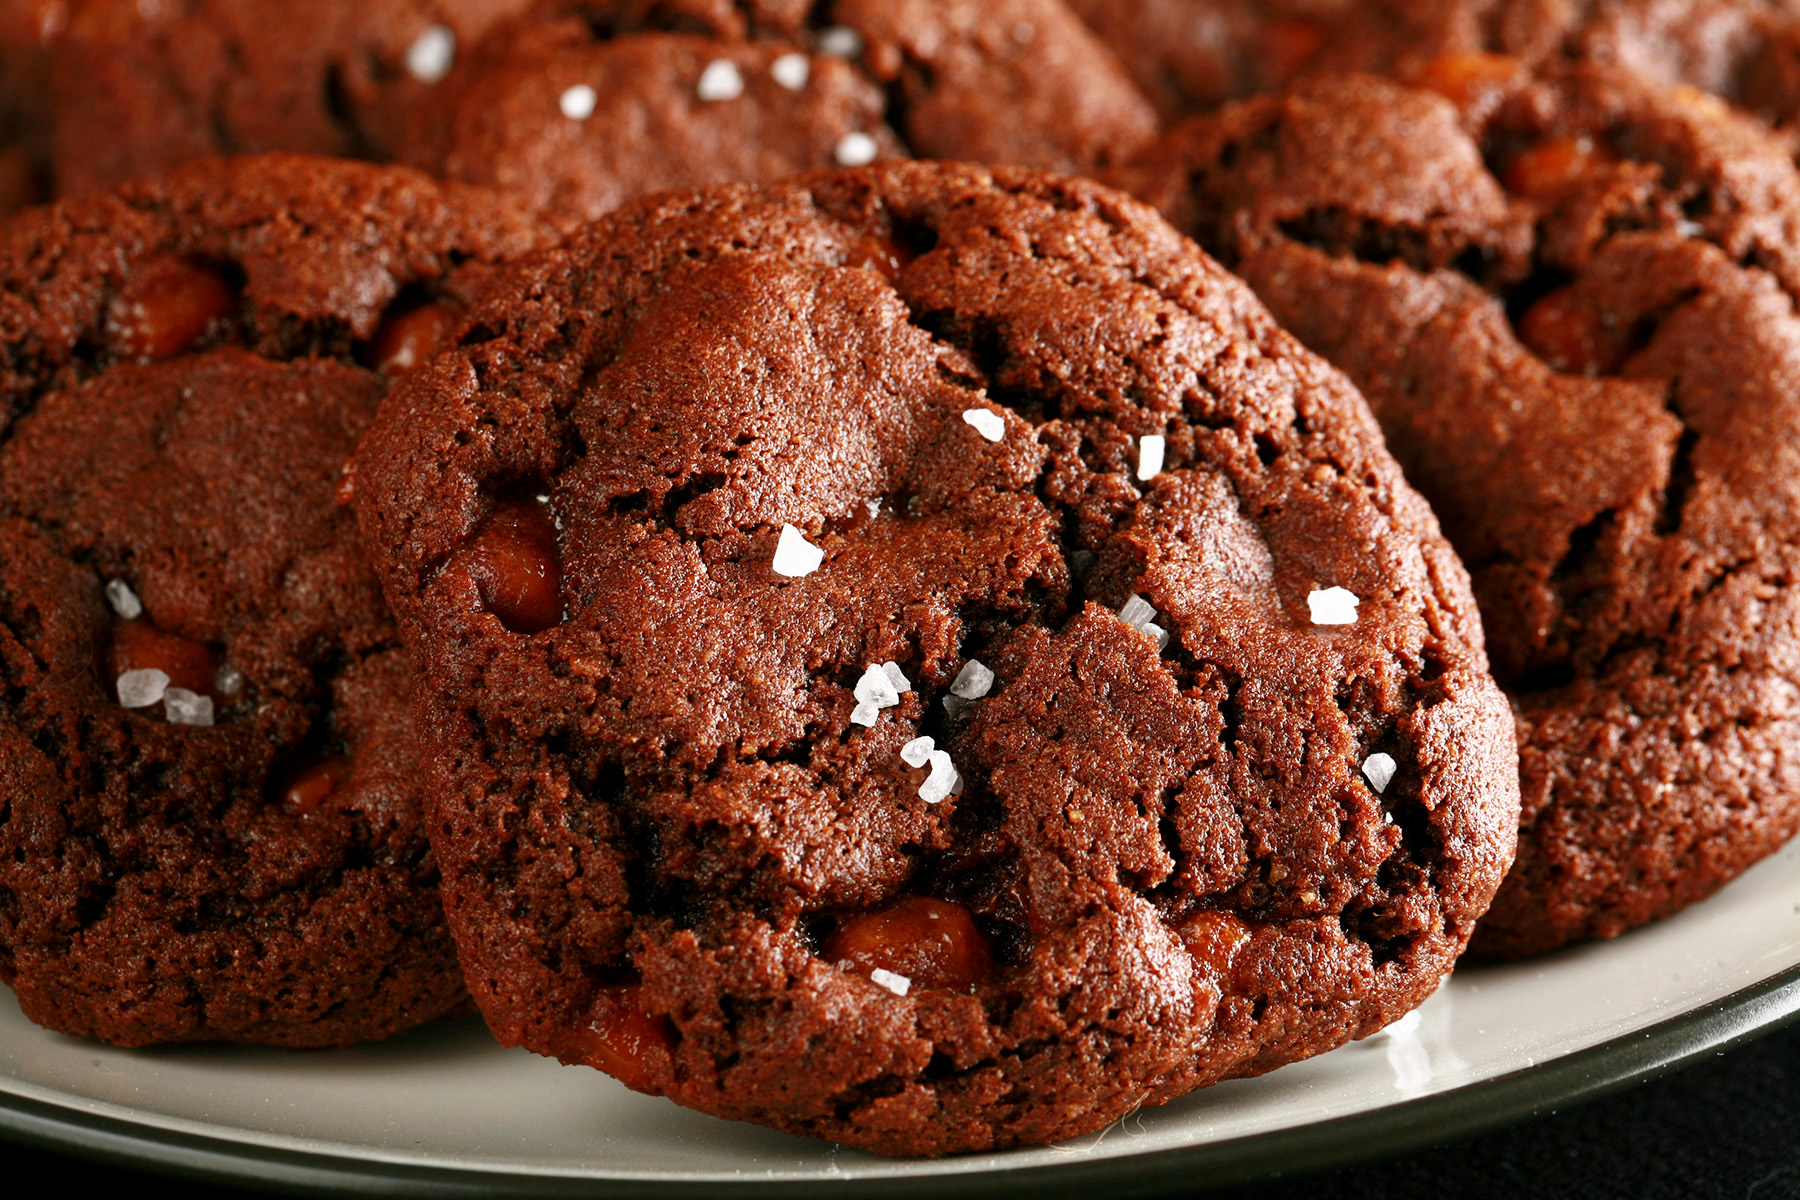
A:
392;0;1156;218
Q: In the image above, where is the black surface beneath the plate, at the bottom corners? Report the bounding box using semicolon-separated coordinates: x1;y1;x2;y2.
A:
14;1024;1800;1200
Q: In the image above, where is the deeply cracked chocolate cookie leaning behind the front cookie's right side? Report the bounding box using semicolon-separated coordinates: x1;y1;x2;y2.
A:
1130;67;1800;957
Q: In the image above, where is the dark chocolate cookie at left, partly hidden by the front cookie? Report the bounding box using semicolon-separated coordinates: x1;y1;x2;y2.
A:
0;157;535;1045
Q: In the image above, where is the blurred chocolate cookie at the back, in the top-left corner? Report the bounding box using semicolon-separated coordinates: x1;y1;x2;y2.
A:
50;0;531;194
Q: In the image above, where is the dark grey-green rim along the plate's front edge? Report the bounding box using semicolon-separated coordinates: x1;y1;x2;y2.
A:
10;964;1800;1200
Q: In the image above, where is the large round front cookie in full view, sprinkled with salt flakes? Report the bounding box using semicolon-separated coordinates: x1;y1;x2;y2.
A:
356;164;1516;1153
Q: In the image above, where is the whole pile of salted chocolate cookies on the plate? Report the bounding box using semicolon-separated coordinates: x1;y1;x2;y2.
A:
0;0;1800;1155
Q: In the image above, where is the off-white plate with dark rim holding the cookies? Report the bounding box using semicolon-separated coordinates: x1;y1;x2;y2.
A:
0;831;1800;1196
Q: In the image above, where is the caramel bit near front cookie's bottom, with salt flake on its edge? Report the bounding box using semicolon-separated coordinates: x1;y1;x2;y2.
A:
824;896;995;995
